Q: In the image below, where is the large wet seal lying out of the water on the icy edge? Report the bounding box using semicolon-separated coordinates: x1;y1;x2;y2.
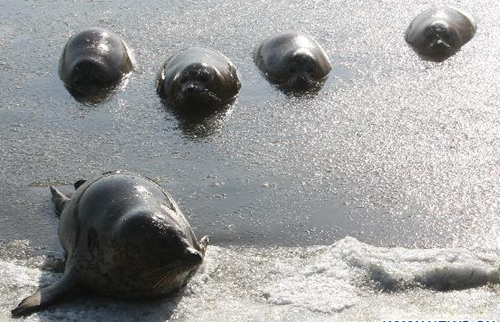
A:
12;171;208;316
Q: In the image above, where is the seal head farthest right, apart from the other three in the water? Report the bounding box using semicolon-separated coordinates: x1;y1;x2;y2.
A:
405;7;477;62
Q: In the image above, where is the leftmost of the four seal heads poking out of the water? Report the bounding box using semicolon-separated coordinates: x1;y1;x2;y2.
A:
59;28;134;94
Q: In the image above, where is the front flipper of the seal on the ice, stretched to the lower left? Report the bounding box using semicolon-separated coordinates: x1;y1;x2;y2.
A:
10;273;78;316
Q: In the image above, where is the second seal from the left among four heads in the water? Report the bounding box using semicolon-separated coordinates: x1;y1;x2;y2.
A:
156;47;241;111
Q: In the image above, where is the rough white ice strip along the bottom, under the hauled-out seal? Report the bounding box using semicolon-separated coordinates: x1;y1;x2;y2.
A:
0;237;500;321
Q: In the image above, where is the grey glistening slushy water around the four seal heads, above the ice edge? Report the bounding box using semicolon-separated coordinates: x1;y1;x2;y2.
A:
0;0;500;252
